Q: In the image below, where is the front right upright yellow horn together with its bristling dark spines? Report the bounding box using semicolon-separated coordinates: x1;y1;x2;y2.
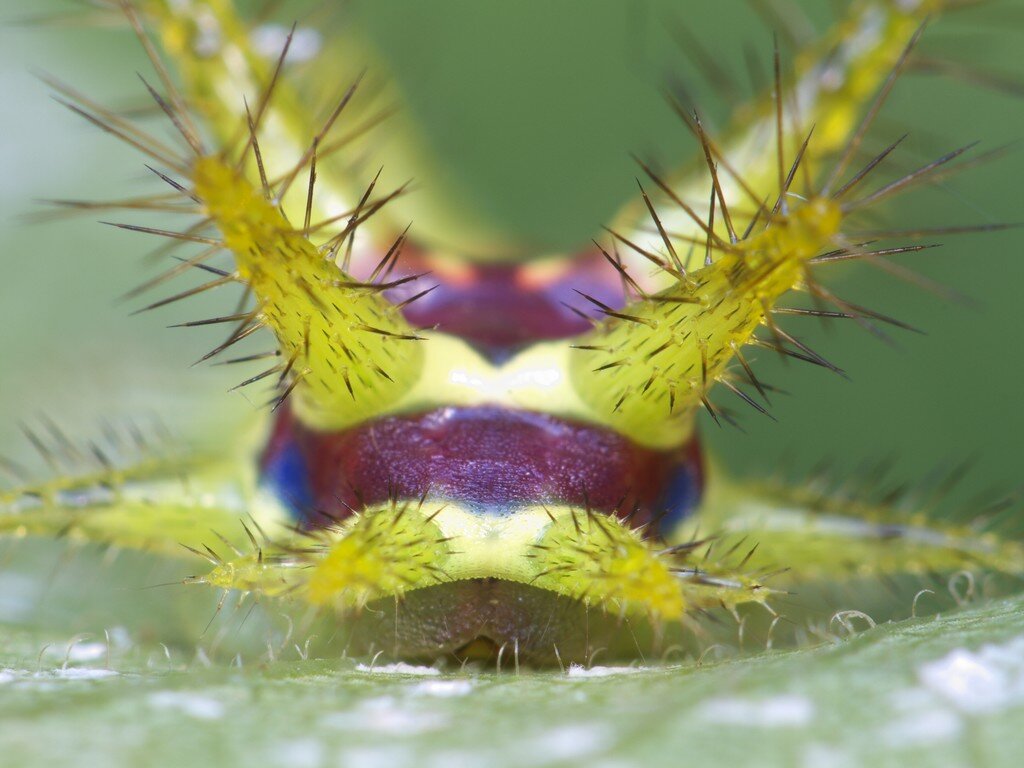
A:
572;1;1002;440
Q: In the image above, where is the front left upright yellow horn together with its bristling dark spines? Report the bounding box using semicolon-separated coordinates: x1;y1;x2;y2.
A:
44;3;425;429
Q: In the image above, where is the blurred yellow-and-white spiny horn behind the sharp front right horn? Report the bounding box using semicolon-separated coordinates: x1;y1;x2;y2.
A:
615;0;937;270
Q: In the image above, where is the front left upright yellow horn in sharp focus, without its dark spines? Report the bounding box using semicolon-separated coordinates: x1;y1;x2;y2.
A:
193;157;423;429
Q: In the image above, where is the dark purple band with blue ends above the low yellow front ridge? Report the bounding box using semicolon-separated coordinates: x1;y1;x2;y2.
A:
261;407;703;527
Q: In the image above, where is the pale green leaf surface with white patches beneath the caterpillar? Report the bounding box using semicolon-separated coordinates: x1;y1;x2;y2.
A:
0;597;1024;768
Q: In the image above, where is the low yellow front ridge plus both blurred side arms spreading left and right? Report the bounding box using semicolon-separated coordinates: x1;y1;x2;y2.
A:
0;430;1024;663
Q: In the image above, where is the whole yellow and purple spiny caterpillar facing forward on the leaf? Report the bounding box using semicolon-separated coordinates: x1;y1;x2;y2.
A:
0;0;1024;664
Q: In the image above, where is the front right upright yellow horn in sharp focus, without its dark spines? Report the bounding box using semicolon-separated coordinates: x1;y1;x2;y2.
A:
570;199;843;442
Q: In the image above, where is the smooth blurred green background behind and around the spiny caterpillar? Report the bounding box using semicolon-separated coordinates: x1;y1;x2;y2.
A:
0;0;1024;487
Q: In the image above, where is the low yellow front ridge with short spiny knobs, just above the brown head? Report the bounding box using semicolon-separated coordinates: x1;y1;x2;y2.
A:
191;501;772;623
